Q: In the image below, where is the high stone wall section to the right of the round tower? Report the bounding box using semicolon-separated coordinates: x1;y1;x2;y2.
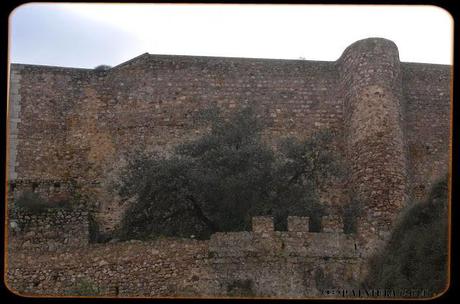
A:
401;63;452;199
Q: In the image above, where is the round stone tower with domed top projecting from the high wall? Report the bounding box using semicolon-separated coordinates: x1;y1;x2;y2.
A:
337;38;407;249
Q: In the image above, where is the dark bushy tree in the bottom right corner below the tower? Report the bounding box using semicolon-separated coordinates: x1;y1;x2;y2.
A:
364;178;448;297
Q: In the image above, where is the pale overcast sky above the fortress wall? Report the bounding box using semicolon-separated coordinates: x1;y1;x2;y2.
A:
10;3;453;68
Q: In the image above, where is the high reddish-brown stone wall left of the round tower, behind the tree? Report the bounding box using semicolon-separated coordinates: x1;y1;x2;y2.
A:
12;55;348;229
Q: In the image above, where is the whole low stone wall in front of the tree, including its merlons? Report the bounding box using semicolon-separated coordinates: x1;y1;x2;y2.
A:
7;217;362;297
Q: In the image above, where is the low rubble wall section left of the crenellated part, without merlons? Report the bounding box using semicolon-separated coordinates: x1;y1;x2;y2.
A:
7;239;211;296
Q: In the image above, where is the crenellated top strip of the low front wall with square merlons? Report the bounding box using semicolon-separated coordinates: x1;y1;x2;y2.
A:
209;216;360;258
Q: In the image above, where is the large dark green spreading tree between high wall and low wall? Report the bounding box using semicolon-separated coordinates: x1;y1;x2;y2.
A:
119;108;342;239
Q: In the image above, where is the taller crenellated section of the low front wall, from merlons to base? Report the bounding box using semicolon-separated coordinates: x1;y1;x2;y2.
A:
208;216;365;297
